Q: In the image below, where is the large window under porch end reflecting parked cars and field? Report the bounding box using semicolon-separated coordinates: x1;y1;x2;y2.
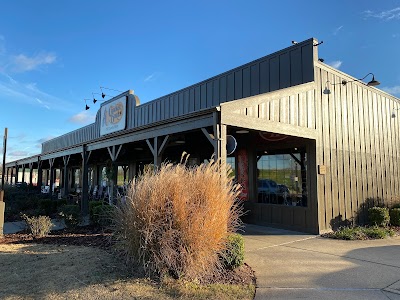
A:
257;148;308;206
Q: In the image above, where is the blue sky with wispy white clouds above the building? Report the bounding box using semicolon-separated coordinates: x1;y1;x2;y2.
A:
0;0;400;162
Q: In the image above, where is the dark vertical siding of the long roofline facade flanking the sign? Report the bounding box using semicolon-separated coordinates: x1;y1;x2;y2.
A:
42;39;316;153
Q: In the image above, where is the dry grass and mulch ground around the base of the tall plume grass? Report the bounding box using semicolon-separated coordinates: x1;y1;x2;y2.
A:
0;228;255;299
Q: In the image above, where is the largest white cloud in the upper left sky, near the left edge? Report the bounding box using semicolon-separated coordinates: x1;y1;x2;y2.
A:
10;53;57;72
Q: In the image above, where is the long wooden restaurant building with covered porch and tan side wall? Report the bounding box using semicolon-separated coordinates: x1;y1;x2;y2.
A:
6;39;400;233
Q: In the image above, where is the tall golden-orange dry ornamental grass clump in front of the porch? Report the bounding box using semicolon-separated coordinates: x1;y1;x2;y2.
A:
115;156;242;279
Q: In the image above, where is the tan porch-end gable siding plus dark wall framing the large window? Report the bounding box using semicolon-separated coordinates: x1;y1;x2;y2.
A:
221;82;318;233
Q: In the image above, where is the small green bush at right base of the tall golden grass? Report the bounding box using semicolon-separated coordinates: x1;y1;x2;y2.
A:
221;233;244;270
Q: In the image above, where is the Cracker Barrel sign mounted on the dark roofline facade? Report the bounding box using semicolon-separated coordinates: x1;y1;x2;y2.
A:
100;96;126;135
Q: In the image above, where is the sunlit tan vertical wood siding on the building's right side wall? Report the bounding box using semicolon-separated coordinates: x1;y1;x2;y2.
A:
316;63;400;231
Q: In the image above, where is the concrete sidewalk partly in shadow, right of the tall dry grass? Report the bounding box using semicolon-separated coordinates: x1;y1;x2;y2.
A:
244;225;400;300
